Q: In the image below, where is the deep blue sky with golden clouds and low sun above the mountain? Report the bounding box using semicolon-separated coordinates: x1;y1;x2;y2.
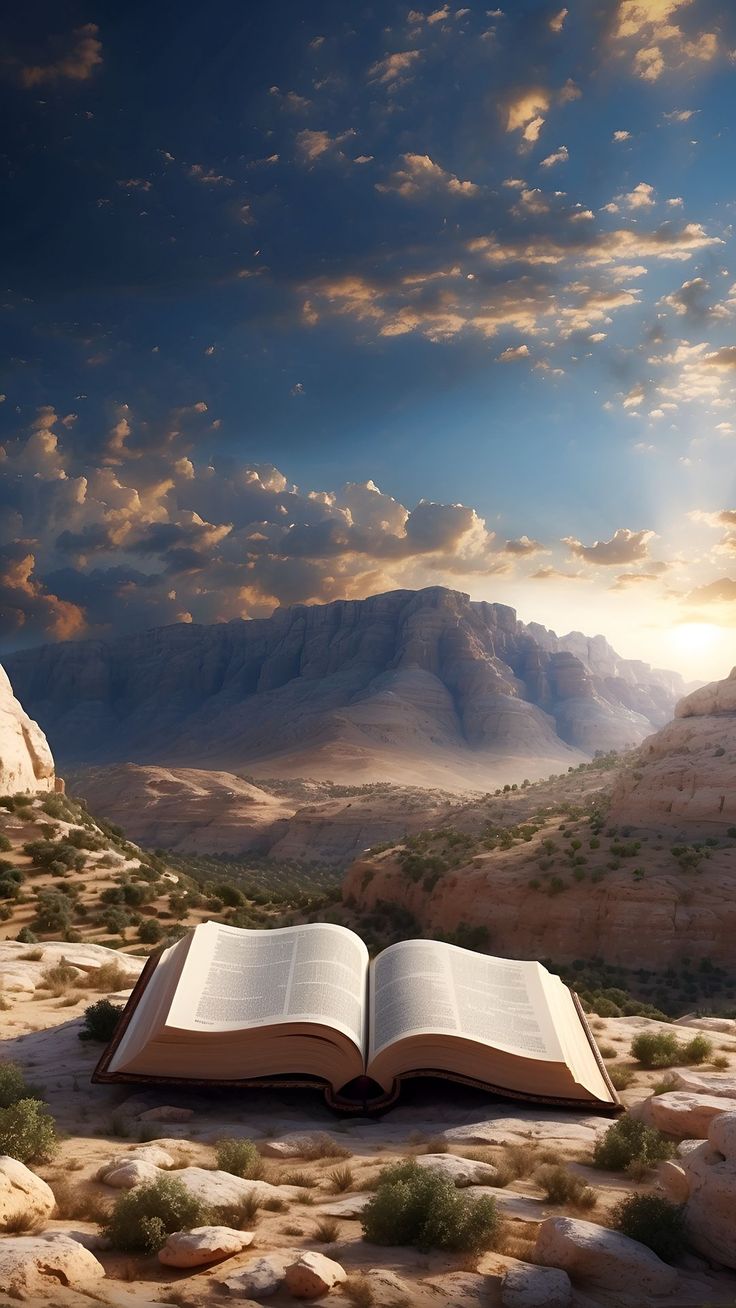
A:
0;0;736;680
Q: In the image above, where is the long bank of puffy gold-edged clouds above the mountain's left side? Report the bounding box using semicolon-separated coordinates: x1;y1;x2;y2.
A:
0;405;541;647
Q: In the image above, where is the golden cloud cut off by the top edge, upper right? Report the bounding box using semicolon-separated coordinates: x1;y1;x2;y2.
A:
611;0;719;81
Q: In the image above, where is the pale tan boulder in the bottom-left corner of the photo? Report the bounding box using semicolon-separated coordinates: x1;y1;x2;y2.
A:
0;1233;105;1304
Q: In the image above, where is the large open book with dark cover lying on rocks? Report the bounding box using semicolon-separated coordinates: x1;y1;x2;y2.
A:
93;922;618;1109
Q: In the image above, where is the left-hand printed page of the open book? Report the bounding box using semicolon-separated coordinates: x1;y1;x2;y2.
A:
166;922;369;1049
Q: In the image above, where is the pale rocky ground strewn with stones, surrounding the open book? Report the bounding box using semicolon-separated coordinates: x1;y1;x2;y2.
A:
0;940;736;1308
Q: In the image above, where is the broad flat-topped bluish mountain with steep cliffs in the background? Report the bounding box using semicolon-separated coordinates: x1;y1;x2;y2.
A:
7;587;684;790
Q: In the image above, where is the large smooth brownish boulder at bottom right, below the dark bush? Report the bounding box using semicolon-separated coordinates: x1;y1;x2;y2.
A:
535;1216;677;1295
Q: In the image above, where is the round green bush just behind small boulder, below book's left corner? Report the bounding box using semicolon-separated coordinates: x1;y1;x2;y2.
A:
102;1176;209;1253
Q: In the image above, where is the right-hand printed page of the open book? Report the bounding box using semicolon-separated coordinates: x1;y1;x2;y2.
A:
369;940;563;1062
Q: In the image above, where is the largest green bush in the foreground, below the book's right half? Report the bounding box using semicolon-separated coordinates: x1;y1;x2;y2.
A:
362;1159;501;1253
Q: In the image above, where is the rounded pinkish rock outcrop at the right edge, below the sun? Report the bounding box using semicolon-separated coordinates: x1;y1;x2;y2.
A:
612;668;736;835
